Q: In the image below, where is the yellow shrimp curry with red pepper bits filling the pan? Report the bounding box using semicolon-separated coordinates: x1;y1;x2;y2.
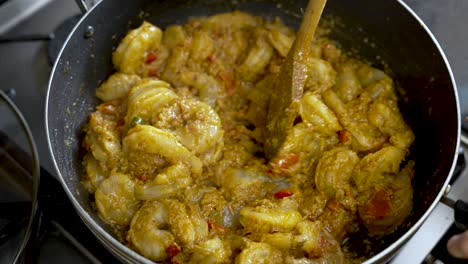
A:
83;12;414;263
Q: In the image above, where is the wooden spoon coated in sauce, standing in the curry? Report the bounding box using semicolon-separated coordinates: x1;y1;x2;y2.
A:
265;0;327;159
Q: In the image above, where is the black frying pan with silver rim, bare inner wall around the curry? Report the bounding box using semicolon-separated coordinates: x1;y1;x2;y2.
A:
46;0;460;263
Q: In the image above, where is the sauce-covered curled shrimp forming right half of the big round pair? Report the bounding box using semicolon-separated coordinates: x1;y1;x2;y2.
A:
153;98;224;164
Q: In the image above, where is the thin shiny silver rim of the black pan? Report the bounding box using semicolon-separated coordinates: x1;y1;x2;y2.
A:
45;0;461;264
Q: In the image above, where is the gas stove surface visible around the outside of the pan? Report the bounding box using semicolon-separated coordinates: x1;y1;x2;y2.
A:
0;0;468;264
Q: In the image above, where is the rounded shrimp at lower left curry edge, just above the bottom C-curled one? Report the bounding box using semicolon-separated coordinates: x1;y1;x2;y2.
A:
94;171;139;226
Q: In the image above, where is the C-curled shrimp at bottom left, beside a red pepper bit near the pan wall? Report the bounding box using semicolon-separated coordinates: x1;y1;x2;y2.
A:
127;201;175;261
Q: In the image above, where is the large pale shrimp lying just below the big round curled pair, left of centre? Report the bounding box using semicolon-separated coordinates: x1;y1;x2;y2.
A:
123;125;202;181
